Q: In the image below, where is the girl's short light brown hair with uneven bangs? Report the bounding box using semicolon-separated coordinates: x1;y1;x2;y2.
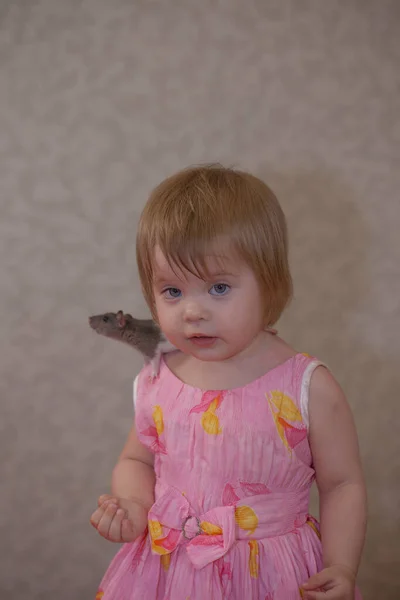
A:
136;165;292;325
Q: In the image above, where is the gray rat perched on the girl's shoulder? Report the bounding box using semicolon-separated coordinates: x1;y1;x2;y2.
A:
89;310;176;378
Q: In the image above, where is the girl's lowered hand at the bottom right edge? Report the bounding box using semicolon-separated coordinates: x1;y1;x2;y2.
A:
303;565;355;600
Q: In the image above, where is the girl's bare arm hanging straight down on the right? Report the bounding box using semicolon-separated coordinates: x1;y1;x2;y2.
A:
306;367;367;598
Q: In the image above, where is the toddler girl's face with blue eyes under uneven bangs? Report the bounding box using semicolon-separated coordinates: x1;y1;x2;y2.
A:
153;248;264;361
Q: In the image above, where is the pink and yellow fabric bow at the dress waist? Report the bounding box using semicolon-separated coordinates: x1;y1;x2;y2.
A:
148;487;236;569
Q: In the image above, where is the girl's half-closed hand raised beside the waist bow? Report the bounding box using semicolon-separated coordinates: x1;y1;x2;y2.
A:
90;494;147;543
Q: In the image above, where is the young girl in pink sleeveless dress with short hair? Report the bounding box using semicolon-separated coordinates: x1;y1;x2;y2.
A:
91;166;366;600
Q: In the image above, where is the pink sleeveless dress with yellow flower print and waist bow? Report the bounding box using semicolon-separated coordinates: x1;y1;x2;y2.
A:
96;353;361;600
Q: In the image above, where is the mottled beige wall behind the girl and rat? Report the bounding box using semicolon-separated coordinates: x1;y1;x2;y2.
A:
0;0;400;600
